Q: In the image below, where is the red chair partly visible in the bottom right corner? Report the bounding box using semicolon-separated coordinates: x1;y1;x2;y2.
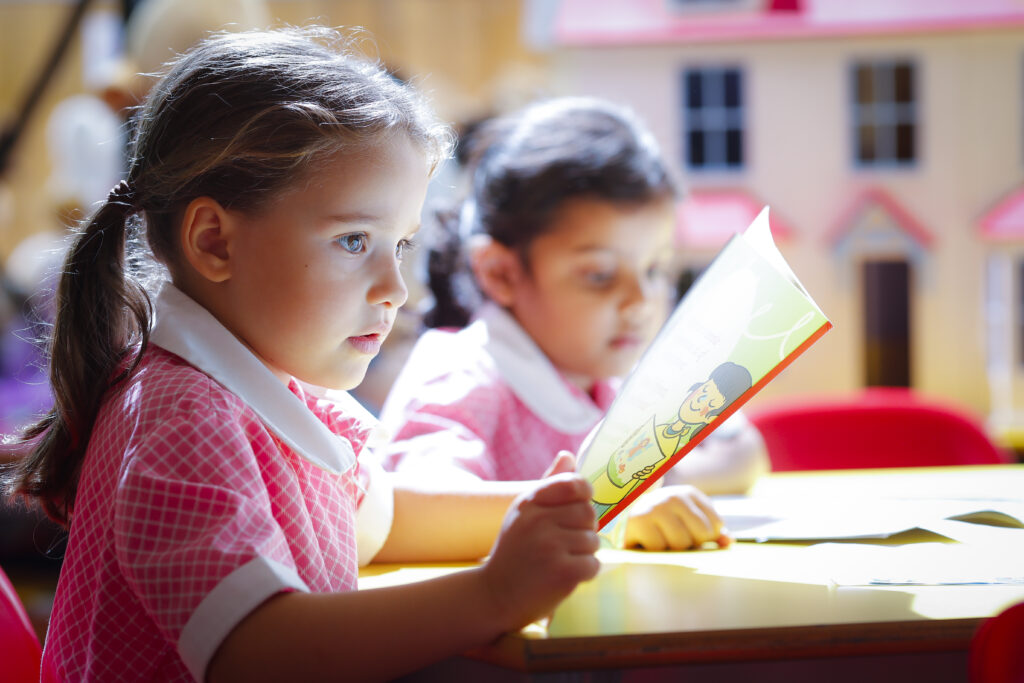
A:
968;602;1024;683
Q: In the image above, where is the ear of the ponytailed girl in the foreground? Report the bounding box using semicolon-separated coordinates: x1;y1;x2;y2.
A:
181;197;234;283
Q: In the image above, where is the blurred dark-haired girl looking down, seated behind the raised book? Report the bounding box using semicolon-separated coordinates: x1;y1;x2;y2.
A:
381;98;767;549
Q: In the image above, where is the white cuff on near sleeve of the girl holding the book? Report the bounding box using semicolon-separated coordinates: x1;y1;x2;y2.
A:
178;557;309;681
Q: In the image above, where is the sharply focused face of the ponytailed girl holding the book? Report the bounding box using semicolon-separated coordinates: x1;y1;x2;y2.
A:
218;135;429;389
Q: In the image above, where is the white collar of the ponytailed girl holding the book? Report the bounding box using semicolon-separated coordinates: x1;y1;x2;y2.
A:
150;283;366;474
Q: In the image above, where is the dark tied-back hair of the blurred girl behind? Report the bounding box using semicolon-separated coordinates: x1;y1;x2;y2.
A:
424;97;678;327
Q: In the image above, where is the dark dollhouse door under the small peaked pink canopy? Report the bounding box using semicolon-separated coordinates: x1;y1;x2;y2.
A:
862;260;910;387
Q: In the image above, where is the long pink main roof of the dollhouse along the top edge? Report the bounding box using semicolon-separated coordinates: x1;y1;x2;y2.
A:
554;0;1024;46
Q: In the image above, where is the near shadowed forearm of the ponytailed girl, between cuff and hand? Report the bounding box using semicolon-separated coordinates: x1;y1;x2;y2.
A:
208;567;514;682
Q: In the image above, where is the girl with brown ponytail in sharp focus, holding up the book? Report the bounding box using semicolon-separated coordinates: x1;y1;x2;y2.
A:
5;29;598;681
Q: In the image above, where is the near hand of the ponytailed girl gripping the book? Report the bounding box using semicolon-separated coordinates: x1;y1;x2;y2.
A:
482;474;600;631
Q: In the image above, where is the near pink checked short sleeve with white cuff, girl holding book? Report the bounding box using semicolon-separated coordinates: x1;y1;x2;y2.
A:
114;410;308;680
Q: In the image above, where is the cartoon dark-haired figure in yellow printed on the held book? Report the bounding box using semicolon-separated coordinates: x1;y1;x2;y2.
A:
591;361;752;517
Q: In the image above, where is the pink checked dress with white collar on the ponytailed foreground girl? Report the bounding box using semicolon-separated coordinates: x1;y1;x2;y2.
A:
43;286;391;682
